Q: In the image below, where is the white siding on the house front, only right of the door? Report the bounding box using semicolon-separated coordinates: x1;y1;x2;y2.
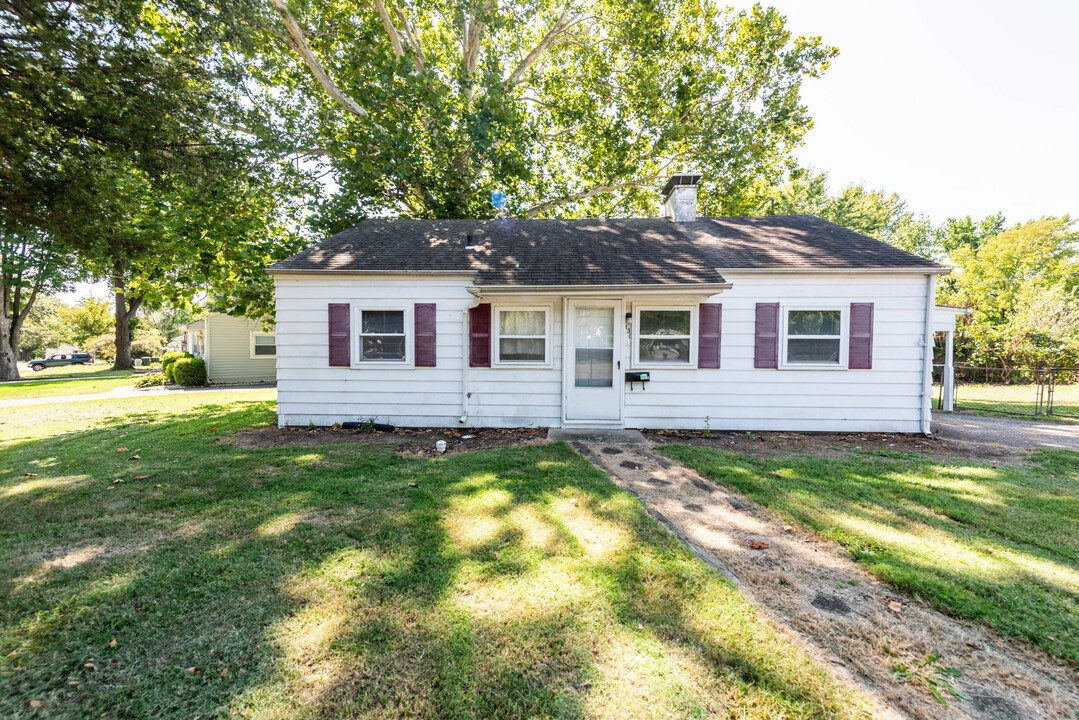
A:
625;274;926;433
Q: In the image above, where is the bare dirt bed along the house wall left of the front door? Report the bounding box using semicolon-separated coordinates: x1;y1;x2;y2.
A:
221;427;547;457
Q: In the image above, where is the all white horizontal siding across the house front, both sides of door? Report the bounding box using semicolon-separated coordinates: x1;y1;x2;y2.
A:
274;274;926;433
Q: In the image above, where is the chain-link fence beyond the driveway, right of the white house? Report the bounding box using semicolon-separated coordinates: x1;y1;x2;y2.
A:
933;365;1079;418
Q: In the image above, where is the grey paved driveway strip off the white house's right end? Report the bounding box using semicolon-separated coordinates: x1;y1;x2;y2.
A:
932;412;1079;450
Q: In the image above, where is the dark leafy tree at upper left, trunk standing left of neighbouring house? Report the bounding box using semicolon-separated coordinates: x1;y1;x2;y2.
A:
0;0;312;368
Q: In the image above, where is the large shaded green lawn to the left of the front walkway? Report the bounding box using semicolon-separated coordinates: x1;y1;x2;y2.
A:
0;390;868;719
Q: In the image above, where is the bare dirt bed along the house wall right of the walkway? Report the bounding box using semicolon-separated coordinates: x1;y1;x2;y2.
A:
641;430;1028;465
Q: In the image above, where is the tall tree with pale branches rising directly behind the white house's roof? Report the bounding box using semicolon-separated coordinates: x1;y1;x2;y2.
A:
251;0;835;225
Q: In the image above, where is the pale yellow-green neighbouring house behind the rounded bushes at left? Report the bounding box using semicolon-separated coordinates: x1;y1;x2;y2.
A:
182;313;277;383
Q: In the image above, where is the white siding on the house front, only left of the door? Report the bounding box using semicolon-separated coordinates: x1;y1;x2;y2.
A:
276;276;562;427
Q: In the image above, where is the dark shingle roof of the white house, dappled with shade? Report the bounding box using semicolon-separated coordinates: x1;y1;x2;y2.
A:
271;215;940;285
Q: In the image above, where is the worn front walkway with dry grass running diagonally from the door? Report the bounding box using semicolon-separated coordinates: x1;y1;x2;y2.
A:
571;440;1079;720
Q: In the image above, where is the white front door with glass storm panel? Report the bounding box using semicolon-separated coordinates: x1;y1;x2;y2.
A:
562;300;625;425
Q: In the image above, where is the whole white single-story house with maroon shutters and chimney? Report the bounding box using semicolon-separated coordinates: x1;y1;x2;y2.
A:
267;175;947;434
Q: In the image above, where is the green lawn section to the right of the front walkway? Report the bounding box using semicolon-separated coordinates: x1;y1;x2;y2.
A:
660;445;1079;661
